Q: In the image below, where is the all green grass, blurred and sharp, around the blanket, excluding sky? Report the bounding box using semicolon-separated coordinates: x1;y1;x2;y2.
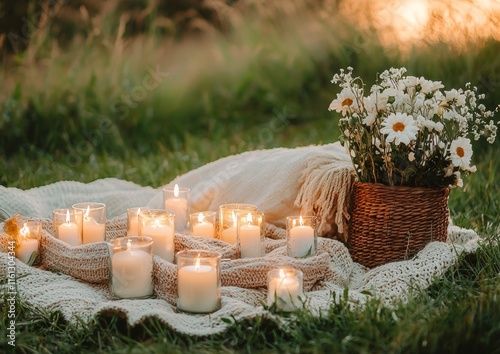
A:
0;1;500;353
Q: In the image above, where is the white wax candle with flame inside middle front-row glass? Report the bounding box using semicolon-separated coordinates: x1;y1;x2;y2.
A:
177;260;219;313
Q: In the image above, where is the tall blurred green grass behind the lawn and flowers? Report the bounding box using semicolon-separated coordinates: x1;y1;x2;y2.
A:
0;3;500;158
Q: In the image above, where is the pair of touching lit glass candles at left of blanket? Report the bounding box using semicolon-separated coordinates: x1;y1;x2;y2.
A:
52;203;106;246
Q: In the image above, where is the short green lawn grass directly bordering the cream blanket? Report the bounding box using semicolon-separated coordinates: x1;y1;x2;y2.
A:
0;126;500;353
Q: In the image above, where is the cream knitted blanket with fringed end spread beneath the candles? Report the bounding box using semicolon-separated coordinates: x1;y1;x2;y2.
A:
0;144;479;335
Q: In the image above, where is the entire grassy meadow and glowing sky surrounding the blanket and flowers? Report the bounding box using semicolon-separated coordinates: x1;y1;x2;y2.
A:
0;0;500;353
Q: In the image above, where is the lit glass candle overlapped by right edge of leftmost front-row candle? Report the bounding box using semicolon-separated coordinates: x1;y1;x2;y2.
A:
139;209;175;262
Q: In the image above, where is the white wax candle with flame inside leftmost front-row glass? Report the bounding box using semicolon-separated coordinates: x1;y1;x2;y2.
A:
111;241;153;298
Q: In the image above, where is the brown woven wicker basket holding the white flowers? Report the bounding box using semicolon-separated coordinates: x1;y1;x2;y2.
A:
348;182;449;268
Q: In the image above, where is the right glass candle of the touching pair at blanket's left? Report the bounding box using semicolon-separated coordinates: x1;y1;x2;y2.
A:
73;202;106;245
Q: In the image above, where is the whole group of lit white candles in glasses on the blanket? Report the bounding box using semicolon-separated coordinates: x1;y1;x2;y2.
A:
24;185;316;313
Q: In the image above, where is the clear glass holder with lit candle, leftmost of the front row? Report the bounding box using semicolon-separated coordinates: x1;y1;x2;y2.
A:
108;236;153;299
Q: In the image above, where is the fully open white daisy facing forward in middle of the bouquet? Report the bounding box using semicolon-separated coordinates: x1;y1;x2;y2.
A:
380;112;419;145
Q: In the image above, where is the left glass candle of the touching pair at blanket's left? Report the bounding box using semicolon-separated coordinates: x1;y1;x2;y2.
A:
52;209;83;246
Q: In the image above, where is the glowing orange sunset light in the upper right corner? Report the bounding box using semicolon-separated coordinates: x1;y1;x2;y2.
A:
340;0;500;51
